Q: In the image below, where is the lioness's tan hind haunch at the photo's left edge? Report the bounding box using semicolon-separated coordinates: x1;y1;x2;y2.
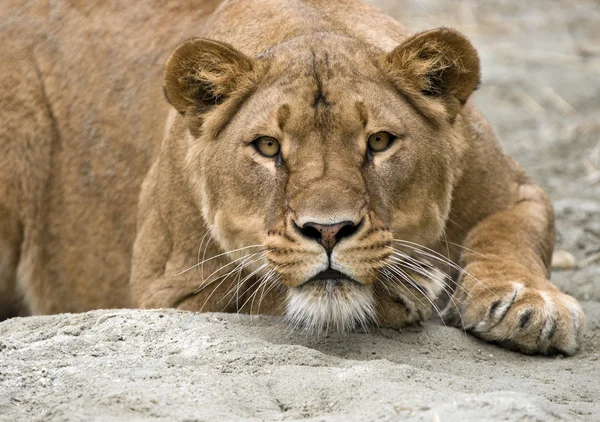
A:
0;46;54;319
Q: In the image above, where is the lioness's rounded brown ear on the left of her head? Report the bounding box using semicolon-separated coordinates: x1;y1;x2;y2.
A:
163;38;256;115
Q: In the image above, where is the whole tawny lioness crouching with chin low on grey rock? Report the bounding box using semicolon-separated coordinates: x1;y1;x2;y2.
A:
0;0;584;354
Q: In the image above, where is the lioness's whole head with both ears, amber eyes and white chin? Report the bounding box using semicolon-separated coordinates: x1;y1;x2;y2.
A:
165;30;479;331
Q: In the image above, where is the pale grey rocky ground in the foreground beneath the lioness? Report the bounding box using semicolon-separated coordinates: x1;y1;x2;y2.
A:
0;302;600;421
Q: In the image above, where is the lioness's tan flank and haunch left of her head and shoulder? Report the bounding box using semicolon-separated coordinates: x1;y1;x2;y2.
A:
0;1;220;314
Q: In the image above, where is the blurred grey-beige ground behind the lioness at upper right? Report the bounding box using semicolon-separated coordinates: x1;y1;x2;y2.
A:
370;0;600;301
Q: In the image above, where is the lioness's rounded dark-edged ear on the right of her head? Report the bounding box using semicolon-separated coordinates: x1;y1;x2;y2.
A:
387;28;481;119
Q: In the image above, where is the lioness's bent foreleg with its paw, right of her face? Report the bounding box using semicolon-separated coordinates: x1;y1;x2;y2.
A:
446;184;584;354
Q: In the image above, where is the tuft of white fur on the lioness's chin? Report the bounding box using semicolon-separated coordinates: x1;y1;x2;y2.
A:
286;280;376;334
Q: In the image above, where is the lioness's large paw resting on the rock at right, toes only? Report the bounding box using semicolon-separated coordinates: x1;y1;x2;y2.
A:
445;282;584;355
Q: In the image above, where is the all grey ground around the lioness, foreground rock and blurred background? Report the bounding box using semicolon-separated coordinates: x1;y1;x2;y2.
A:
0;0;600;421
